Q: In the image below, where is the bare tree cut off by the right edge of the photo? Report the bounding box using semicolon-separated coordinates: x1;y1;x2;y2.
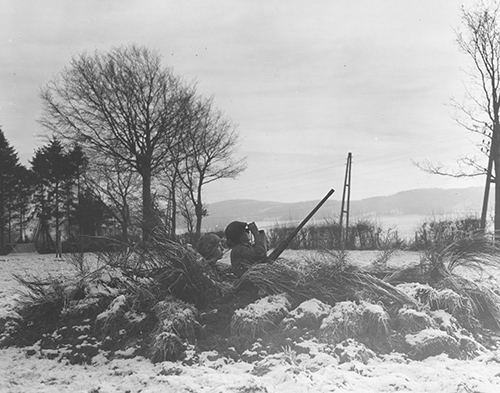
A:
417;2;500;231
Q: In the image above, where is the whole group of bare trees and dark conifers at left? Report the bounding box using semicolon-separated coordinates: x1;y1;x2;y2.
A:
0;46;245;252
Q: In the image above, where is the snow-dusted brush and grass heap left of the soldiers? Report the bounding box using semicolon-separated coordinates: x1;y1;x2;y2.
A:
0;233;218;363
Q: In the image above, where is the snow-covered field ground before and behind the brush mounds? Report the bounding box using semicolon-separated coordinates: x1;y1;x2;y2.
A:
0;251;500;393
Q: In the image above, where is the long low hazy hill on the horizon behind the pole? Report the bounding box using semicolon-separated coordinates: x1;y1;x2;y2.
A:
203;187;483;230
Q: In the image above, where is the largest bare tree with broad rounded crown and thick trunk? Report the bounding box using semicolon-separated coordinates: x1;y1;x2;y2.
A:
41;46;193;241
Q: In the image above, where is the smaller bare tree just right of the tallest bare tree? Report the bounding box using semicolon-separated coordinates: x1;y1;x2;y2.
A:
178;99;245;242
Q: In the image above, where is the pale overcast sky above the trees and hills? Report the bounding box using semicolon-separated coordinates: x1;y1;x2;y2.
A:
0;0;483;202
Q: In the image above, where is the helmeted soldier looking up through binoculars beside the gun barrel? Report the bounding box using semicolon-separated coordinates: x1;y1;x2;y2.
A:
225;221;268;277
